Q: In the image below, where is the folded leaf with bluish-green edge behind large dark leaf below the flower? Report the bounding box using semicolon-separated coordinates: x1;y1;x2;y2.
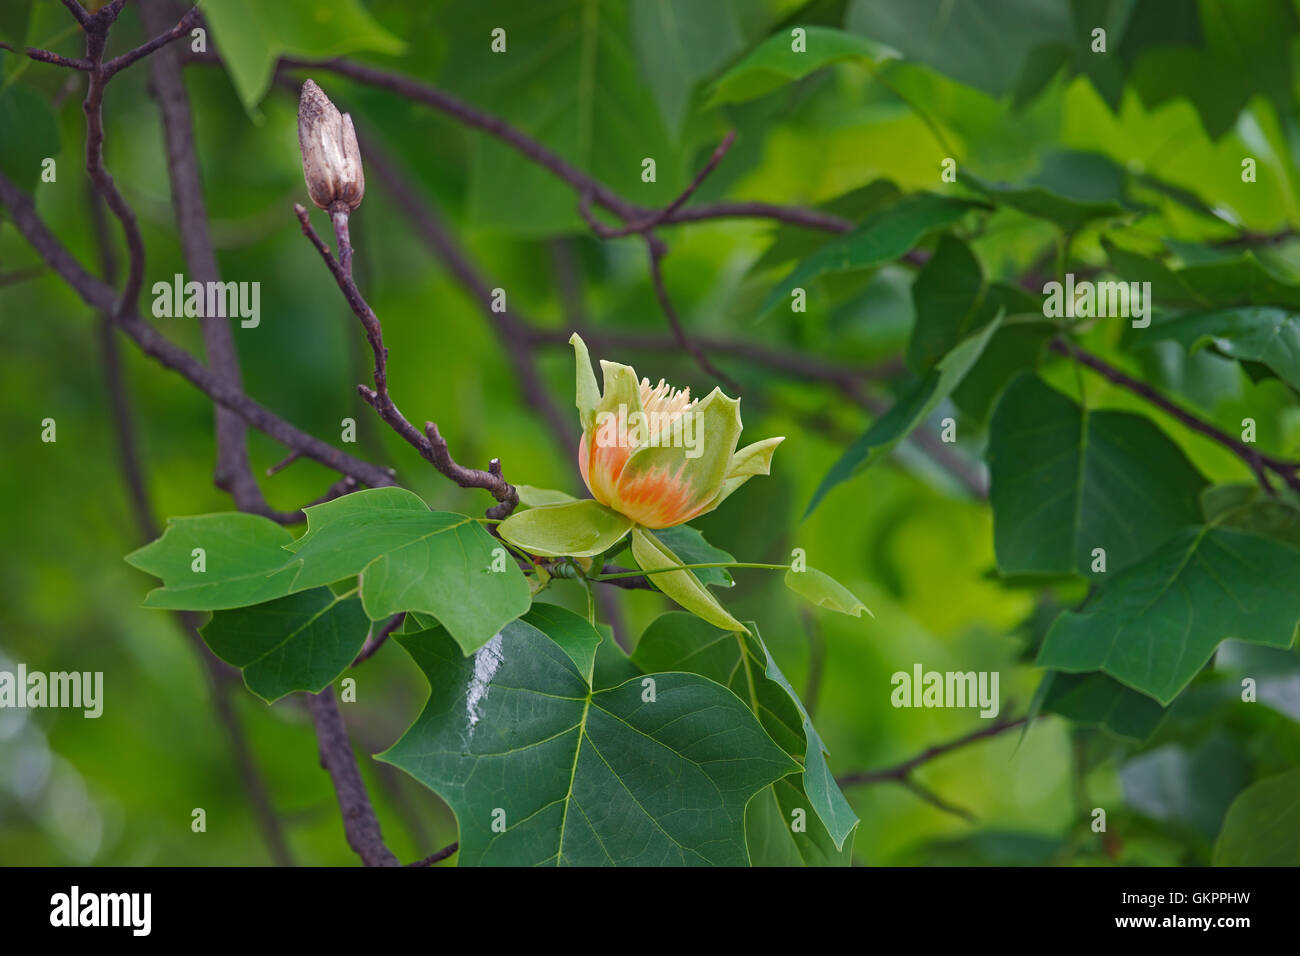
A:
632;611;858;857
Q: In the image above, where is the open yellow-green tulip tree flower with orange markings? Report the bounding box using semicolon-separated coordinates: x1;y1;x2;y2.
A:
499;334;784;631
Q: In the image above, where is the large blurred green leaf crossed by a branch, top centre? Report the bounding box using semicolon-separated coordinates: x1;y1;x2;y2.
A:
437;0;696;235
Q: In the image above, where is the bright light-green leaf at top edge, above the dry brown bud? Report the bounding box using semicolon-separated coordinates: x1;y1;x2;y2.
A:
203;0;406;112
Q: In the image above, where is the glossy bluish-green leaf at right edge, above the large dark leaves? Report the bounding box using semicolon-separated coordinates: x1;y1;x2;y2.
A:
1131;307;1300;389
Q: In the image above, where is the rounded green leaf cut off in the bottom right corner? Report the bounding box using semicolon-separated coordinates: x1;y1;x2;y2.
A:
1214;767;1300;866
